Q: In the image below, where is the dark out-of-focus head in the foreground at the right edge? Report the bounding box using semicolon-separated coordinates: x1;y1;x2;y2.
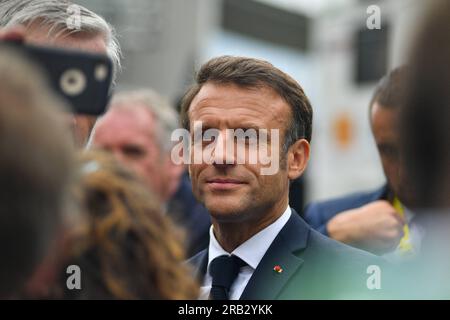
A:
402;0;450;209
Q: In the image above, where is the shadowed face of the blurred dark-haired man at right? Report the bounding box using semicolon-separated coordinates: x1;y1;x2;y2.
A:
371;102;404;201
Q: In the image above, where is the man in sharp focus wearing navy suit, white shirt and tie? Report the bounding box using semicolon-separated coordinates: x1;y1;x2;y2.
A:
181;56;381;300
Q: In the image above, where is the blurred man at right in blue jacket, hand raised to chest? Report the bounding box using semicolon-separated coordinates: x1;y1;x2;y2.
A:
304;67;423;259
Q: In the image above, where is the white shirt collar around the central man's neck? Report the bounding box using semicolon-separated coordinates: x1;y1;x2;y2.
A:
208;206;292;269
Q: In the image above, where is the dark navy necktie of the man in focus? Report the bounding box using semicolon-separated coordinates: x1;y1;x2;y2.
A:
209;255;247;300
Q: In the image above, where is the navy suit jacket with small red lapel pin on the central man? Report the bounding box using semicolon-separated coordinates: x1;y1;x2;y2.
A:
188;210;384;300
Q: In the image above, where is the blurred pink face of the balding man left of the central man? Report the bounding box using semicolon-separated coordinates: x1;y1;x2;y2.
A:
92;105;173;201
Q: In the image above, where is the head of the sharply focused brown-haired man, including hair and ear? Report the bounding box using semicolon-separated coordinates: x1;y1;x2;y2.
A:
181;56;312;228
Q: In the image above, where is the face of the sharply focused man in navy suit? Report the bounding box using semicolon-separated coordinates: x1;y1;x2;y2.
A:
189;83;291;222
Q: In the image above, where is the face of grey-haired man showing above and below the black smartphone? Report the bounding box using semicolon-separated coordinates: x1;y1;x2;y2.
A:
24;25;107;148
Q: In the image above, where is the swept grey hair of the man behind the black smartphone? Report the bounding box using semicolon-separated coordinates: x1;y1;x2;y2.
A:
0;0;122;82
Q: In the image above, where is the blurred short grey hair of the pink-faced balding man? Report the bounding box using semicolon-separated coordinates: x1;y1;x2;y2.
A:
110;89;179;152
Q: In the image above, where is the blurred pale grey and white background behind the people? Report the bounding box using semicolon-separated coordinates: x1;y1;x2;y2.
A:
77;0;426;202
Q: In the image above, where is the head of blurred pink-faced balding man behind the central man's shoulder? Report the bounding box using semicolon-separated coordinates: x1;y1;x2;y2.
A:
90;89;184;202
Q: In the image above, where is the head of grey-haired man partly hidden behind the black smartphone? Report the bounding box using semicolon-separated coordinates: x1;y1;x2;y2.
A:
0;0;121;147
